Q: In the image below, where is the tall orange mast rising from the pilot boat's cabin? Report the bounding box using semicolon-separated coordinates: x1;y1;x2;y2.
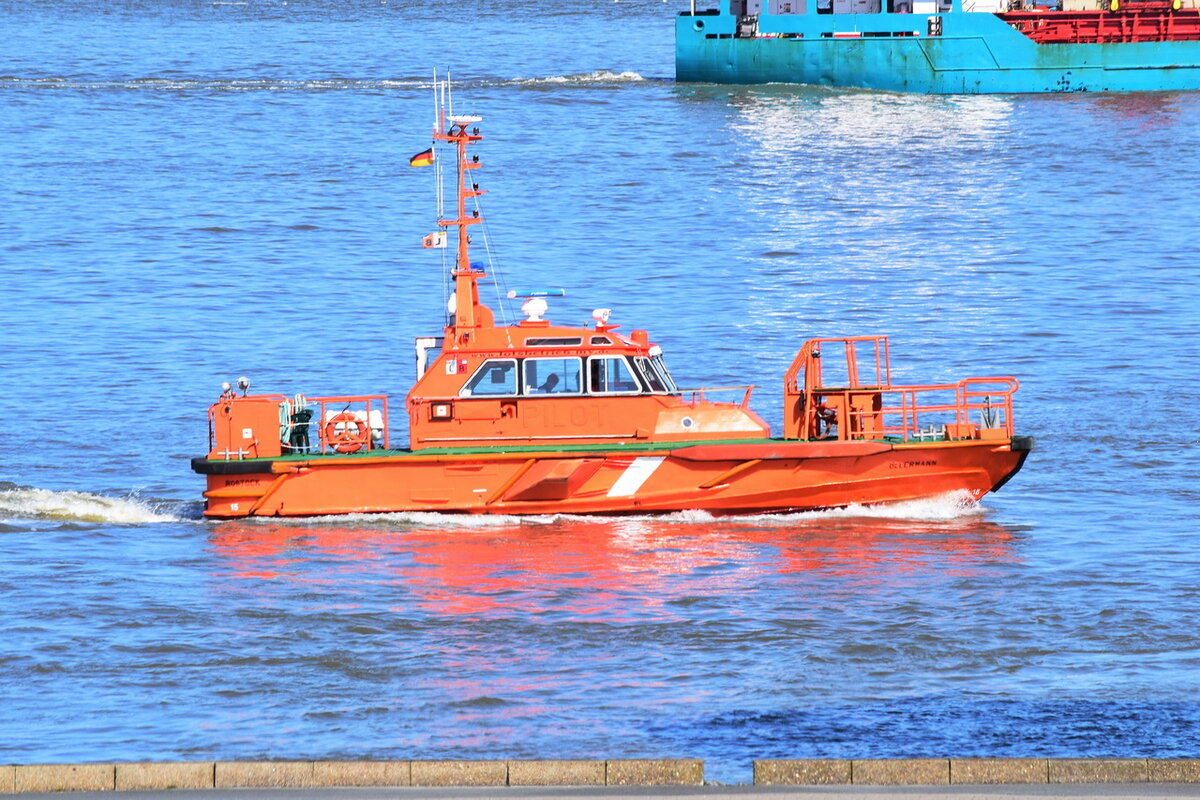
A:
433;100;493;344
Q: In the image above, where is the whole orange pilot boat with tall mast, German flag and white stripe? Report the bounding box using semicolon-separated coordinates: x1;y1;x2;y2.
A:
192;86;1033;518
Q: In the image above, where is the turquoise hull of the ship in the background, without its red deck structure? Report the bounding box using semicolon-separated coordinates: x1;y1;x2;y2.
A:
676;4;1200;95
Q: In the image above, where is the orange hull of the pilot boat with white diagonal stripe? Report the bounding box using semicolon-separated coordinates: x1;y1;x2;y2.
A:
193;437;1032;518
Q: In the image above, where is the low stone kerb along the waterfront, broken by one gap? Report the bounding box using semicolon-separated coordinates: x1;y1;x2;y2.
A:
11;758;1200;794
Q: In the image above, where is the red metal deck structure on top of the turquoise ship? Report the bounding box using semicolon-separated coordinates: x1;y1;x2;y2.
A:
997;0;1200;44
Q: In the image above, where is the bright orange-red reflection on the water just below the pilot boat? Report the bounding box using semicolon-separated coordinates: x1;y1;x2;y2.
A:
211;503;1018;621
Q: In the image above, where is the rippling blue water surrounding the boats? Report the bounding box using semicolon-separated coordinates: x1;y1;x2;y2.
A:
0;0;1200;782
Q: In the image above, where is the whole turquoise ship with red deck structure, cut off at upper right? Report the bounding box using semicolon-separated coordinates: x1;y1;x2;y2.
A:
676;0;1200;95
